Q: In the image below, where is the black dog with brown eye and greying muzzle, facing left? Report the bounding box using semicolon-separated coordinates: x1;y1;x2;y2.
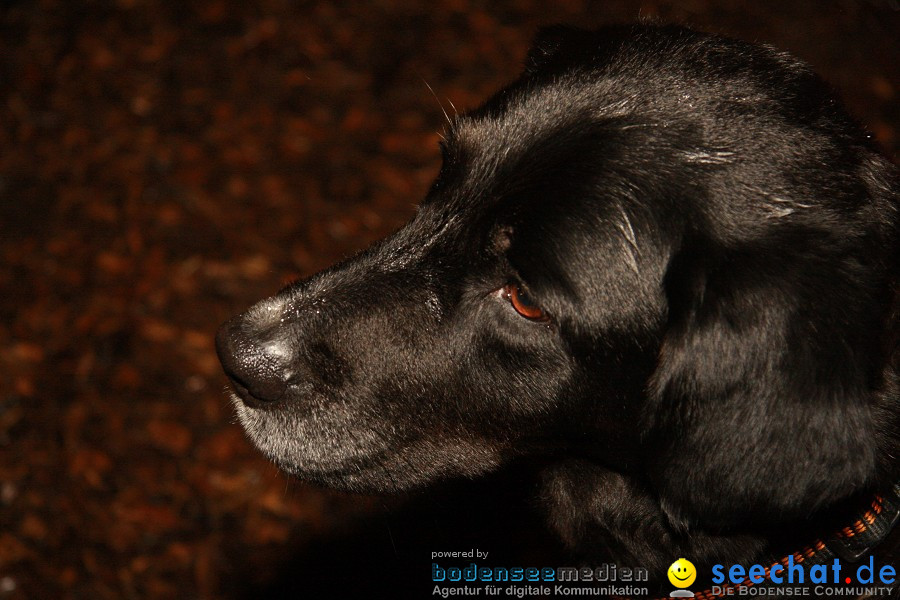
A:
217;25;900;596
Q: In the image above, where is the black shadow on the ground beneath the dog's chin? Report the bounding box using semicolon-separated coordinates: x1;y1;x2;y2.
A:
232;470;570;600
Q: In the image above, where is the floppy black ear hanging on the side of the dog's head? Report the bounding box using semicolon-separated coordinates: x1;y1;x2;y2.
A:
646;231;884;529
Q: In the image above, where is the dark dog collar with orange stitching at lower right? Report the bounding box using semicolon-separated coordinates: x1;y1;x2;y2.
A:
622;483;900;600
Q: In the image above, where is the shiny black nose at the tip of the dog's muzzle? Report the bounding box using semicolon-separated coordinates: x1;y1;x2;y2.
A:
216;315;291;402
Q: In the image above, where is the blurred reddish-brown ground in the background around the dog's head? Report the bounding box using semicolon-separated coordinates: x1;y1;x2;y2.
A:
0;0;900;599
